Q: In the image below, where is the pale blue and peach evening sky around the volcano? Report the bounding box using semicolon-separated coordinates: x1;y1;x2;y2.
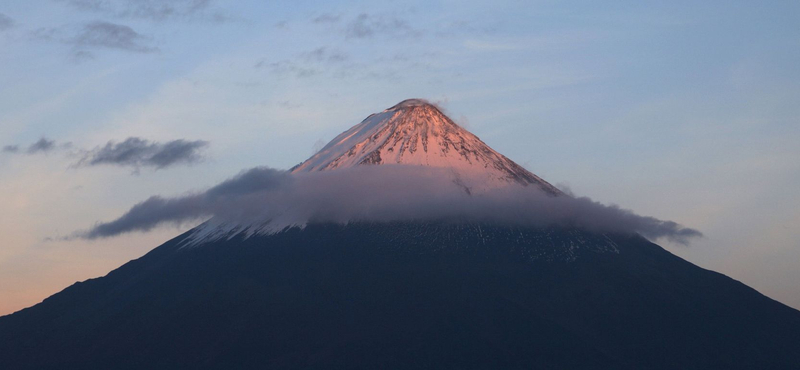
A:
0;0;800;315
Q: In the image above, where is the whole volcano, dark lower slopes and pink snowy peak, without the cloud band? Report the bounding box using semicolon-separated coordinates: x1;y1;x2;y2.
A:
0;99;800;369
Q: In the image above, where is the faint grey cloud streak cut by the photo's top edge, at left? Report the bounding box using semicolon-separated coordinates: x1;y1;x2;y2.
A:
57;0;231;22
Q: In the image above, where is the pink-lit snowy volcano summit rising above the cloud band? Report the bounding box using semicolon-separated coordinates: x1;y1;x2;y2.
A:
292;99;561;195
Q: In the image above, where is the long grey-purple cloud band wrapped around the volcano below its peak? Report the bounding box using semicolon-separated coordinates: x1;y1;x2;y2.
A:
75;166;702;244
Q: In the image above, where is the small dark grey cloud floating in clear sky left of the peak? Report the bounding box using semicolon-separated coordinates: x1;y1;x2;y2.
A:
76;137;209;169
